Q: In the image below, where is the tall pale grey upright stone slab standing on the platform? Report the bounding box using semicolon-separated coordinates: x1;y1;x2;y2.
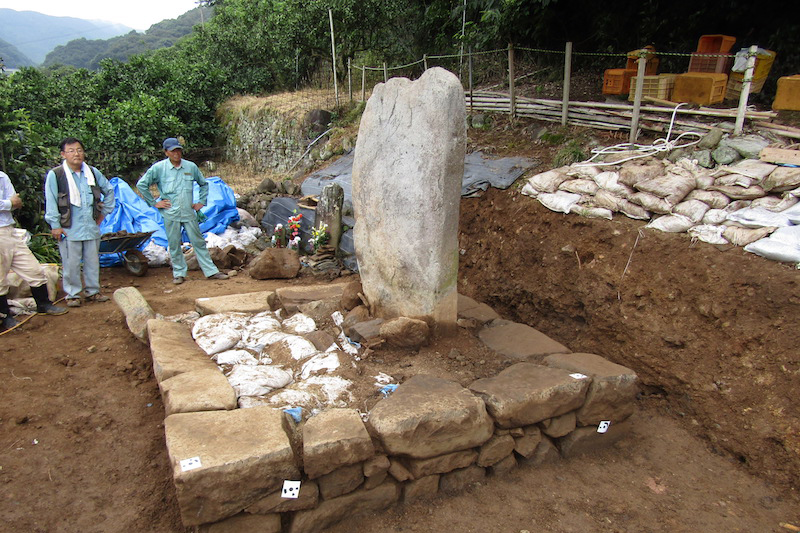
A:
353;68;466;334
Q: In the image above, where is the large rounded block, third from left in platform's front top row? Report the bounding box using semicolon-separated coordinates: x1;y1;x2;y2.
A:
367;375;494;459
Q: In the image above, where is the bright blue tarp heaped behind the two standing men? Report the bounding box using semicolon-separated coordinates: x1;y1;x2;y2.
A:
100;176;239;266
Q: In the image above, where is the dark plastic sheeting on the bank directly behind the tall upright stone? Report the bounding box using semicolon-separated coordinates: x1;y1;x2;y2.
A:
301;151;537;201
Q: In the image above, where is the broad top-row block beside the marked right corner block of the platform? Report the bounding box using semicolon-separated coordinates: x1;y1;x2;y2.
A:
468;363;589;428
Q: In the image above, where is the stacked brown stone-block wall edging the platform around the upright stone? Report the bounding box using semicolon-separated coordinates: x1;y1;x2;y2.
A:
134;288;637;533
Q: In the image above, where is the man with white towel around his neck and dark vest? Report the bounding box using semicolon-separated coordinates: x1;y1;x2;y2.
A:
44;137;115;307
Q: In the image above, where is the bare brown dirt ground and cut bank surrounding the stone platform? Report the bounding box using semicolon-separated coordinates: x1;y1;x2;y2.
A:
0;121;800;533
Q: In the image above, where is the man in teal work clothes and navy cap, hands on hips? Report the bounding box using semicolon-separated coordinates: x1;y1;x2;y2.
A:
136;137;228;285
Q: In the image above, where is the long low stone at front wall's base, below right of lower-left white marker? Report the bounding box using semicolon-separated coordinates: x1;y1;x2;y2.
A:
289;481;400;533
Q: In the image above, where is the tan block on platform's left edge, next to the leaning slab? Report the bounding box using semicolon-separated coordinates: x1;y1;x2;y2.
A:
147;320;219;383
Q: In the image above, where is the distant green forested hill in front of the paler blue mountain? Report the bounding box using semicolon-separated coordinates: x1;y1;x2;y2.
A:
44;7;213;70
